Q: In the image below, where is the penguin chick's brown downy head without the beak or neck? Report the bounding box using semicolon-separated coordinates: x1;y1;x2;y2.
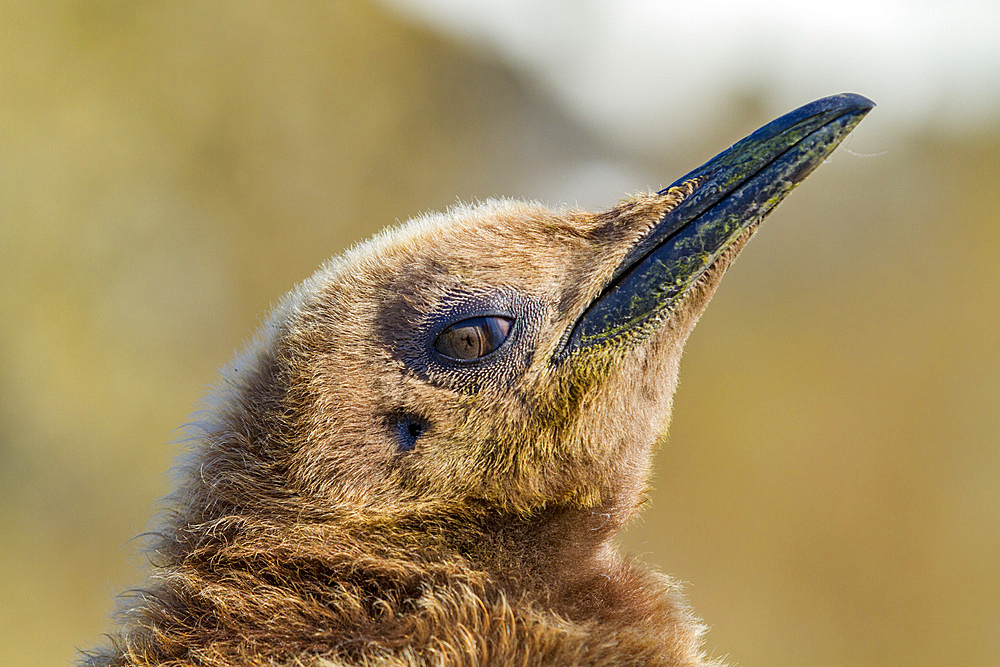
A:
279;194;708;513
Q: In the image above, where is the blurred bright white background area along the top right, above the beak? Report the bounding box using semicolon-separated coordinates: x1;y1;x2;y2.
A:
385;0;1000;150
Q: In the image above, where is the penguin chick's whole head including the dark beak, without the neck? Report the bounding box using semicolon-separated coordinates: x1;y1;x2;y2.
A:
207;95;872;523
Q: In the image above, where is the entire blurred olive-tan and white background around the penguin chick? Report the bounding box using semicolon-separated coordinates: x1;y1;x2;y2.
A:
0;0;1000;667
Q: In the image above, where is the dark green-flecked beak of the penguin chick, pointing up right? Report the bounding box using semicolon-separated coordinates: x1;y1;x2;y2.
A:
562;94;875;356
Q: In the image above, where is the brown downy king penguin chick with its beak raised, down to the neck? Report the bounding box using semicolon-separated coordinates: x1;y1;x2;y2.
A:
84;94;873;666
